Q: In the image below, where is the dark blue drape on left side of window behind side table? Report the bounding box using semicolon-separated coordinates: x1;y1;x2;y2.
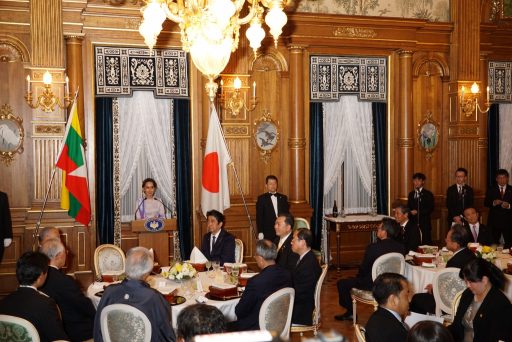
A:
309;102;324;250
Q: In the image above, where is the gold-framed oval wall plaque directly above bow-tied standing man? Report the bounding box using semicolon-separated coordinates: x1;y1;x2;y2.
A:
253;110;279;164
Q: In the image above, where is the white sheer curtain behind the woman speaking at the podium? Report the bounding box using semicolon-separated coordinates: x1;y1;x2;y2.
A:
119;91;176;222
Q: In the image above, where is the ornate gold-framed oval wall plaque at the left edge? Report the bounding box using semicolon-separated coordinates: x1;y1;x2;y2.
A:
0;104;25;166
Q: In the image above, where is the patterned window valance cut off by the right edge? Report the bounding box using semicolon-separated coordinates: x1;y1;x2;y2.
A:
488;61;512;102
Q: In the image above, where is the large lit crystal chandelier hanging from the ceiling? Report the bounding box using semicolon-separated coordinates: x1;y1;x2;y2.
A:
139;0;291;101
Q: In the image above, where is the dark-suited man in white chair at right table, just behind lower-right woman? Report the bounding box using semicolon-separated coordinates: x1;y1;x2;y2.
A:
410;224;476;314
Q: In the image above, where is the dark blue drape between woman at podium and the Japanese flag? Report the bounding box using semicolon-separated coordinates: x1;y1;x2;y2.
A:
174;100;192;259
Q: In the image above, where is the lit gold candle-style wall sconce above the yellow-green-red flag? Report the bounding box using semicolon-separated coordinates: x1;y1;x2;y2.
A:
25;70;71;113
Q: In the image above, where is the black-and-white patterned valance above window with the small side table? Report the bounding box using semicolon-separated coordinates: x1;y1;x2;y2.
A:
310;56;387;102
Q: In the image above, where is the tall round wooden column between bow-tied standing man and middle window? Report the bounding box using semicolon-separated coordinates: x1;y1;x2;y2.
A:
288;45;306;203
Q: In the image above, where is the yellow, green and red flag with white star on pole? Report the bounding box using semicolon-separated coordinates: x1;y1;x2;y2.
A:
55;98;91;226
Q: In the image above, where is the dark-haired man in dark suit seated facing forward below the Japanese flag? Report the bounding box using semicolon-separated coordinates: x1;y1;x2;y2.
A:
201;210;235;266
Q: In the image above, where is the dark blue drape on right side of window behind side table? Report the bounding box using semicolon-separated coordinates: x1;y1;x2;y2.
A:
372;102;388;215
